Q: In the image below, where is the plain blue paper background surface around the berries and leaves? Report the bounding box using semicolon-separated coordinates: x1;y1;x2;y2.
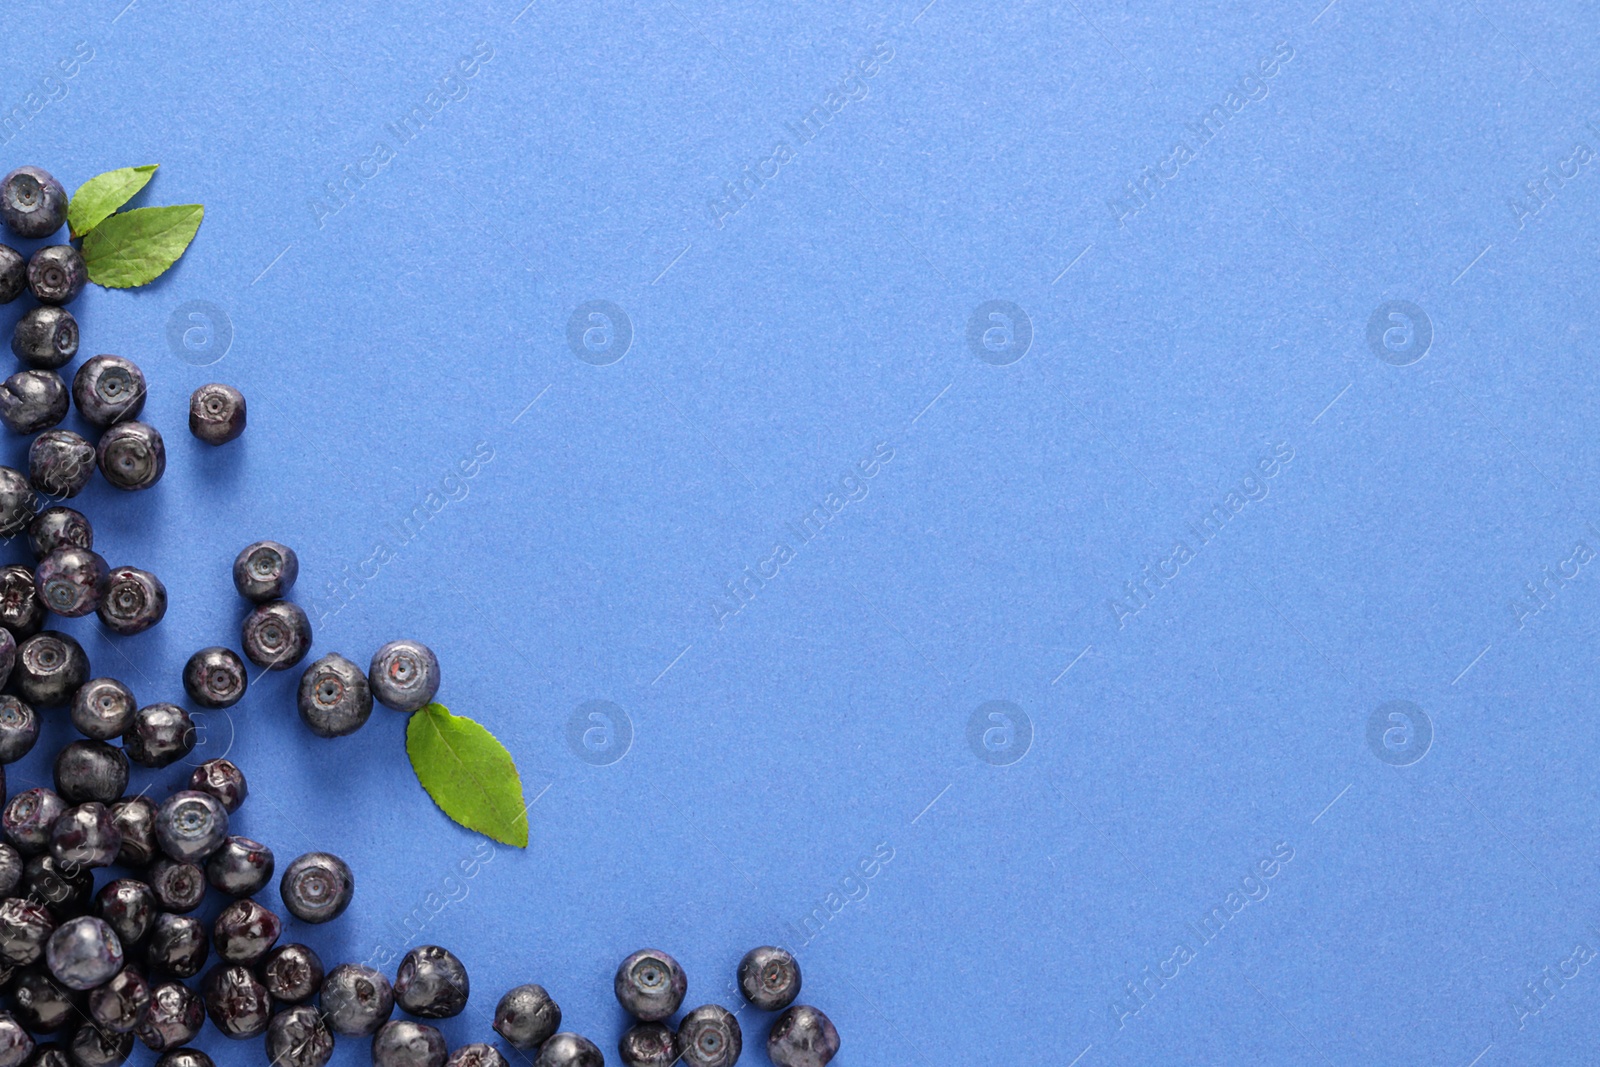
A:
0;0;1600;1067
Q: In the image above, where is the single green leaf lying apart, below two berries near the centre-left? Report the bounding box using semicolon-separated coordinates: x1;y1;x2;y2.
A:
405;704;528;848
